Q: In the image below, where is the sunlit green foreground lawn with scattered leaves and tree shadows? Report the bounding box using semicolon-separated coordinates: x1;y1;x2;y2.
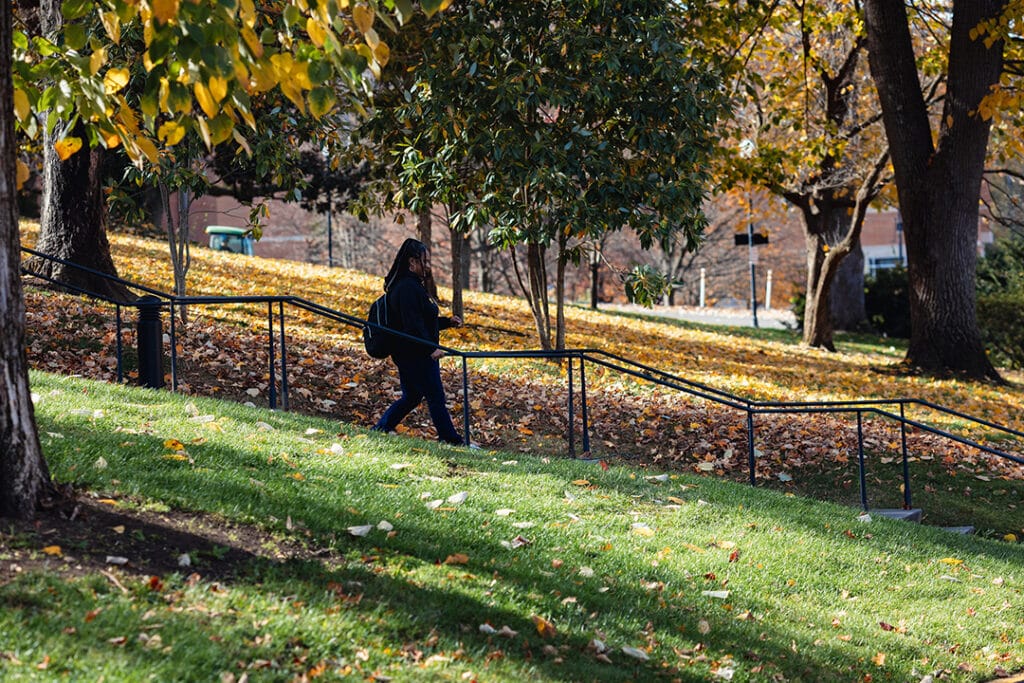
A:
0;373;1024;681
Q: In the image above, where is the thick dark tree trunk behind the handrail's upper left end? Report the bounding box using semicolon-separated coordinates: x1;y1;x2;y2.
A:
26;0;135;302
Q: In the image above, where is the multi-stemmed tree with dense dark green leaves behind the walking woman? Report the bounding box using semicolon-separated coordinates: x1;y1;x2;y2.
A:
356;0;725;348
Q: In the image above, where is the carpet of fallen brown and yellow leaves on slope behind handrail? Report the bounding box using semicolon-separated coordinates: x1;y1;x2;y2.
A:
27;236;1024;489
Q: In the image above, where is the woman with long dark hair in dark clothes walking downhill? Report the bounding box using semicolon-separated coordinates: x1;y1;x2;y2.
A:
373;239;463;443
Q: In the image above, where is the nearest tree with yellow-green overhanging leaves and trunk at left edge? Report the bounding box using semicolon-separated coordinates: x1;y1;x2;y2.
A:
0;0;446;516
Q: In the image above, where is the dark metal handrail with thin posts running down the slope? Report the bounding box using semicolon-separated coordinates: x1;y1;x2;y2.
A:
22;247;1024;518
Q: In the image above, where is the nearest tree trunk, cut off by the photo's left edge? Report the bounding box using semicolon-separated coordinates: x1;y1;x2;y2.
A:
0;3;51;518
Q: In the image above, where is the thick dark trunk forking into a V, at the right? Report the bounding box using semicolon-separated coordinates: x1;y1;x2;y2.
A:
864;0;1006;380
